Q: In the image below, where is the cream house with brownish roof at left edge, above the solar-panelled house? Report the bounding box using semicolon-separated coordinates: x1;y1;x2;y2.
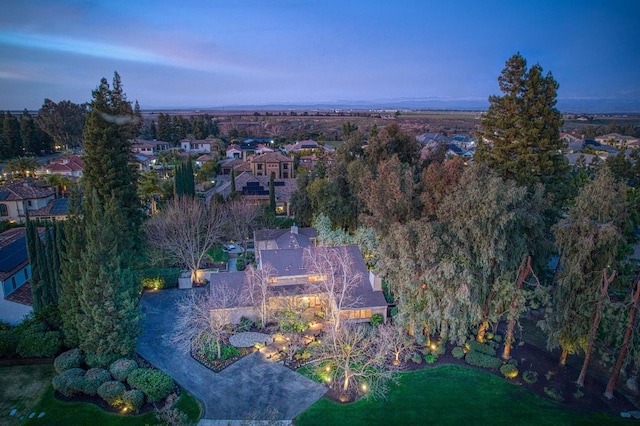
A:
0;178;55;223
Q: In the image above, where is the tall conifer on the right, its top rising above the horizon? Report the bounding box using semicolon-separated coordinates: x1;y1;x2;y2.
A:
474;53;568;194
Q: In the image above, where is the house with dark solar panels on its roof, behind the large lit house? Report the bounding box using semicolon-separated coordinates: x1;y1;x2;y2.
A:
205;171;297;216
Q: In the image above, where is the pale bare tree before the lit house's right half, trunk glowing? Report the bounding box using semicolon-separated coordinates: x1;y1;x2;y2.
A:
304;247;365;330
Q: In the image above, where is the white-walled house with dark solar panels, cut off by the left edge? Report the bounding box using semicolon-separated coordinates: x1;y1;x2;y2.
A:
0;228;33;324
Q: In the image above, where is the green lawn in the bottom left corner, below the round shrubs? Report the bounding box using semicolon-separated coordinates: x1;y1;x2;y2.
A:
0;364;200;426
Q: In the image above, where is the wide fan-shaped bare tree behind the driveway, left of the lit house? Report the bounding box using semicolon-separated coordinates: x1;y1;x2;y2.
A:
145;197;224;280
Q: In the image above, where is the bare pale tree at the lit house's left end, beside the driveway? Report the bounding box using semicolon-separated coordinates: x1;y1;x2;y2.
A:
171;283;238;358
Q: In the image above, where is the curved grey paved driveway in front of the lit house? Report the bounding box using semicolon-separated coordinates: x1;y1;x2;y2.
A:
136;289;326;420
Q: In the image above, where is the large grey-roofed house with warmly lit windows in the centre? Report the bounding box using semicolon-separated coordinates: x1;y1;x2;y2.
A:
211;226;388;322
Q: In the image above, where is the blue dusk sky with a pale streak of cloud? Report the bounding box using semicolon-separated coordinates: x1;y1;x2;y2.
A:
0;0;640;109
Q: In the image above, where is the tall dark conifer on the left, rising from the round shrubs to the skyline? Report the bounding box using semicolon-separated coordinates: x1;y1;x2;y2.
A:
62;73;142;364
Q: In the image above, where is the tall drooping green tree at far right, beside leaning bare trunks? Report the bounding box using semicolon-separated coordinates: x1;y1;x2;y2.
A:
540;168;626;365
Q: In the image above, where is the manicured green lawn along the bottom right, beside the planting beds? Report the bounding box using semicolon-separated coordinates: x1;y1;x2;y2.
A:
295;365;633;426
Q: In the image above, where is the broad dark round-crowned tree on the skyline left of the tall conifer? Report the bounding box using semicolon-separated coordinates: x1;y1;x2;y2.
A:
36;99;87;149
